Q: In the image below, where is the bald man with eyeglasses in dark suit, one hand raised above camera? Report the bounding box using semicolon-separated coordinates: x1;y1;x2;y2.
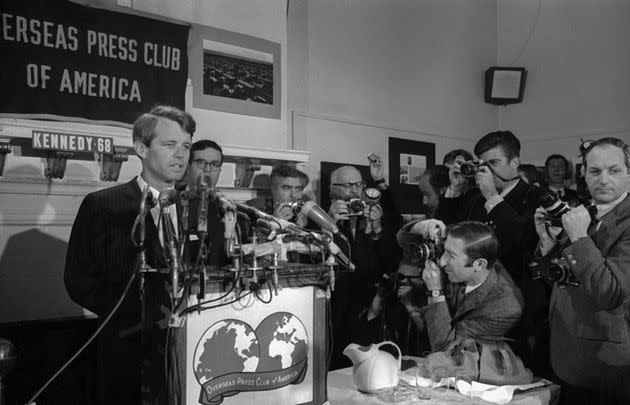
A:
329;157;401;369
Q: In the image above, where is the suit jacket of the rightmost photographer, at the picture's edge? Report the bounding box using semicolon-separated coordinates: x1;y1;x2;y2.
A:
550;196;630;404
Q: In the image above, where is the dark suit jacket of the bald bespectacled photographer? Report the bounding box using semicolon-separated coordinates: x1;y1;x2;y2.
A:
331;189;401;369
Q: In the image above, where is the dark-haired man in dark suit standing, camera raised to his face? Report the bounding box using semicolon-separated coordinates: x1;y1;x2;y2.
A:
435;131;549;376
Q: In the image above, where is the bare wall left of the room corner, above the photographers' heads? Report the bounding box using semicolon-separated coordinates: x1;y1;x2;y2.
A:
289;0;497;197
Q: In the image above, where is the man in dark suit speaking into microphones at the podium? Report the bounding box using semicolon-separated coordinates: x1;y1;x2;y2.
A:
64;106;196;405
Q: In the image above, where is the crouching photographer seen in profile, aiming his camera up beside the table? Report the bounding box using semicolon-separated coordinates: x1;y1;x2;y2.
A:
398;219;523;351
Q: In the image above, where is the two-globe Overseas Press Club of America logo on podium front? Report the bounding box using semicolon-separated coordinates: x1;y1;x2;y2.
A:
193;312;308;405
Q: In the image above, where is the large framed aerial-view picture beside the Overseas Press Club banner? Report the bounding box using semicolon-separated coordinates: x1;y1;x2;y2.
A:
188;24;281;119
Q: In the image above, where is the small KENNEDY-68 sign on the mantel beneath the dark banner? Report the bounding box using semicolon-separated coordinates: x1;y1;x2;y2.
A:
33;130;114;153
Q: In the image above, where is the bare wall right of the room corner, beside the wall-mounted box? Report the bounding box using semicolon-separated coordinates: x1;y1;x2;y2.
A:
497;0;630;161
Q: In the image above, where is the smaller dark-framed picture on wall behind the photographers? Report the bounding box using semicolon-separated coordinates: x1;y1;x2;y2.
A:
389;137;435;214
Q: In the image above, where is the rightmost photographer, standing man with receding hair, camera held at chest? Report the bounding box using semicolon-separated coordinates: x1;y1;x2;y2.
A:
535;138;630;404
